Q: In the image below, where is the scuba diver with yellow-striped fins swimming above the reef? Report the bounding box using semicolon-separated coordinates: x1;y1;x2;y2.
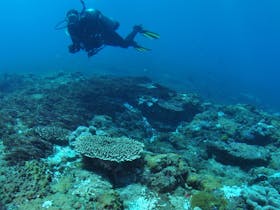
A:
58;0;160;57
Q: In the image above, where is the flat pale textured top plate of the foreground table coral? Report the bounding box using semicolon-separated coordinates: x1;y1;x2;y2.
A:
75;134;144;163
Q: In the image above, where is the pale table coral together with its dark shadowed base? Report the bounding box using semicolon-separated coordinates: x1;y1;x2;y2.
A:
71;128;144;186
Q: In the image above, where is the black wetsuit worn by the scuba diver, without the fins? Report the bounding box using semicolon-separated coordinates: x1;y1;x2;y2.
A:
67;10;140;56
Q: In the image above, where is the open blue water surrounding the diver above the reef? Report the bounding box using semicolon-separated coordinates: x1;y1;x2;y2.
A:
0;0;280;111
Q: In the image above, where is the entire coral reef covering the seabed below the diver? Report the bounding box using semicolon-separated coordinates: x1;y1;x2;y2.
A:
0;73;280;210
